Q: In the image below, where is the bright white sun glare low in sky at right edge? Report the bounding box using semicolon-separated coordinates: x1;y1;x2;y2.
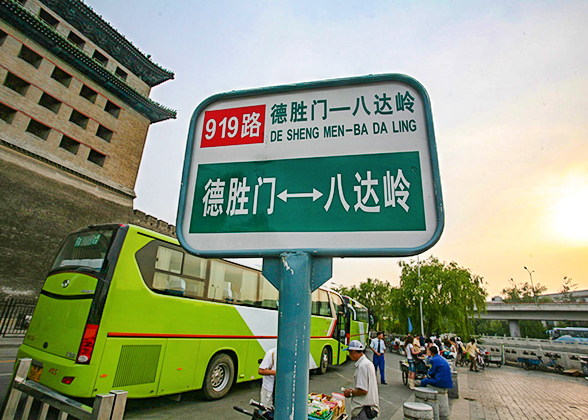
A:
552;178;588;245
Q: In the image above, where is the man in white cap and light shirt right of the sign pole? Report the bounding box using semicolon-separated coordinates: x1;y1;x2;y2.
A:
343;340;380;420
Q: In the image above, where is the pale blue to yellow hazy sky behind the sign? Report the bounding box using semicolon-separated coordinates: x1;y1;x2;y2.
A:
92;0;588;296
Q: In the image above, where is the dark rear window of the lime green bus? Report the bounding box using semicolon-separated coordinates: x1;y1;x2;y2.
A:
51;227;114;273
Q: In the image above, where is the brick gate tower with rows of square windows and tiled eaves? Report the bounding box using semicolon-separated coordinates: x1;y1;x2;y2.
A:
0;0;176;295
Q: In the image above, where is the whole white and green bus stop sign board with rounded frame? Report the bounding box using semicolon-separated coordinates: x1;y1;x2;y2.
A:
177;74;443;257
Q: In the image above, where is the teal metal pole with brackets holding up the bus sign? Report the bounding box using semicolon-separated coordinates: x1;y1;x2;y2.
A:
263;252;332;420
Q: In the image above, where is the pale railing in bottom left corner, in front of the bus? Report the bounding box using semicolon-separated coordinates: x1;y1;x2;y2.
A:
2;359;127;420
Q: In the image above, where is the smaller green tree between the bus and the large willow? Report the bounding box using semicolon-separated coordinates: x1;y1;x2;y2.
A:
334;278;394;331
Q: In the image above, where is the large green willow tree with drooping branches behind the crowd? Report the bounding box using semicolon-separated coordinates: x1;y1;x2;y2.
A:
392;256;488;337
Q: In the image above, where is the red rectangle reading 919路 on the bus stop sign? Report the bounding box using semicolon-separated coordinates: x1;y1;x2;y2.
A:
200;105;265;147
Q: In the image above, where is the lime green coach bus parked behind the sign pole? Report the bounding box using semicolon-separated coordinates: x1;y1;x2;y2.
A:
18;224;369;399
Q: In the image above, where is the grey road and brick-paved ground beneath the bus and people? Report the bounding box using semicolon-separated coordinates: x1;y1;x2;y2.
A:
0;339;588;420
